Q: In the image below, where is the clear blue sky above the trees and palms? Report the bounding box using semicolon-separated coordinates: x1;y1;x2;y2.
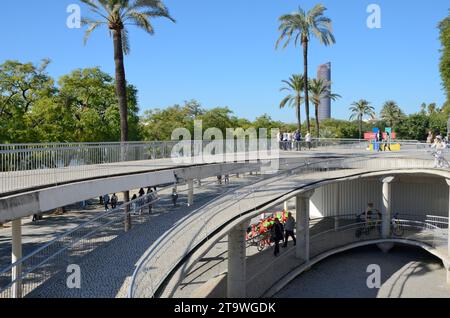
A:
0;0;450;122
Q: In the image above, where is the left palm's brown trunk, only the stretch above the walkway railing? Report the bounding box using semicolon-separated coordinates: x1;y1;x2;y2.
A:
113;30;128;142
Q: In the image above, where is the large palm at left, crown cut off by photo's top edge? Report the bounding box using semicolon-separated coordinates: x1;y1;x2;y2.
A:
81;0;175;142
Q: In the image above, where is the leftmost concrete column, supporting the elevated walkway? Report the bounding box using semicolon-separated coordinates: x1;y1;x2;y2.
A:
11;219;22;298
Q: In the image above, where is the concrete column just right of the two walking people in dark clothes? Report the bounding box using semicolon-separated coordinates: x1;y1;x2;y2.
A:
295;190;314;262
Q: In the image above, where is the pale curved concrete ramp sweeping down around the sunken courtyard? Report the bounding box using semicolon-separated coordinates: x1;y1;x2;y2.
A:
132;154;450;297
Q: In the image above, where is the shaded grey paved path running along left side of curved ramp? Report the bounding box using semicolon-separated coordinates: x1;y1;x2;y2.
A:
17;175;257;298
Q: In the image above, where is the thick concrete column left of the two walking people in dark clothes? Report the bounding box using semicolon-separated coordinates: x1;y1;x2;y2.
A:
227;223;248;298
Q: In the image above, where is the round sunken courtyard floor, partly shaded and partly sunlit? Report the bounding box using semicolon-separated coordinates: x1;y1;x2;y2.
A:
275;246;450;298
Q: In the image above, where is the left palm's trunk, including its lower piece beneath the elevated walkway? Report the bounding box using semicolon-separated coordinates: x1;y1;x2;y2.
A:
113;30;131;231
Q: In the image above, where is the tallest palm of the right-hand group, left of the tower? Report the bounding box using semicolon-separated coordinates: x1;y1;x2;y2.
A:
276;4;336;131
